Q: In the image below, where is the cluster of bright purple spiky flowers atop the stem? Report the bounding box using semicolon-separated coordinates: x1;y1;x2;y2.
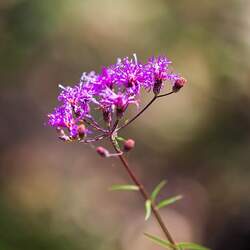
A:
48;55;186;141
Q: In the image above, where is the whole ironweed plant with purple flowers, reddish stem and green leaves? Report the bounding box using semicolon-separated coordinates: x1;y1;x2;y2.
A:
48;54;207;250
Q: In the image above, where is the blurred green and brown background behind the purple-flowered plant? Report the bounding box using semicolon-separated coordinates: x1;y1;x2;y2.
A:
0;0;250;250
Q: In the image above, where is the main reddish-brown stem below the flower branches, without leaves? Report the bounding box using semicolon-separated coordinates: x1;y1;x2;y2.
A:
110;137;177;250
